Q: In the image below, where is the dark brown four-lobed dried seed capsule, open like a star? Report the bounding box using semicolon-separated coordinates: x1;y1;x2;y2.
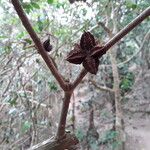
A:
66;32;106;74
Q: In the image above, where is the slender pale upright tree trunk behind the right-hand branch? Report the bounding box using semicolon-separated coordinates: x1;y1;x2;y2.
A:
109;6;125;150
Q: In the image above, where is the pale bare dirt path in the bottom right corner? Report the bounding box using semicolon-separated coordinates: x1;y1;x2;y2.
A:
125;117;150;150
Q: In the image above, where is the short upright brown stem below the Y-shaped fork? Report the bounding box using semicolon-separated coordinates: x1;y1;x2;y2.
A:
56;91;72;139
